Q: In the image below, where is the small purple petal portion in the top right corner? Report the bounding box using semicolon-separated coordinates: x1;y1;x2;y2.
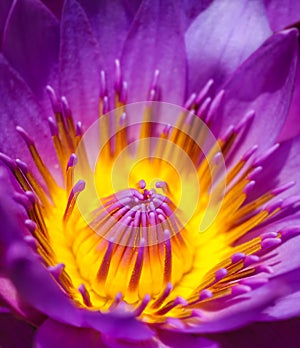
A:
264;0;300;31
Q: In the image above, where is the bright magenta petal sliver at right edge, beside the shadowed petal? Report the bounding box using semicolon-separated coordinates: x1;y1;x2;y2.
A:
279;58;300;141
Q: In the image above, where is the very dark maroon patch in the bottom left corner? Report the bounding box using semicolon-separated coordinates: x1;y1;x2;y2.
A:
0;313;35;348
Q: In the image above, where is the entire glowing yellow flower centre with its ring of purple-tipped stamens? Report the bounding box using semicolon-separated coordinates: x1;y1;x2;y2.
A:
0;64;297;327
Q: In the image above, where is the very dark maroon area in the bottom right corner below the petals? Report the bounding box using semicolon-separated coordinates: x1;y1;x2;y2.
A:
212;318;300;348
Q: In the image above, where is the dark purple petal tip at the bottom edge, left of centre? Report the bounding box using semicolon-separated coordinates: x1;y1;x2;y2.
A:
34;319;106;348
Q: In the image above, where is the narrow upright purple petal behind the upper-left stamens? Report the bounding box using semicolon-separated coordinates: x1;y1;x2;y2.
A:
60;0;100;125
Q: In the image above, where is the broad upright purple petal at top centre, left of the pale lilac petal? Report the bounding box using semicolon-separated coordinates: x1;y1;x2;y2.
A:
121;0;186;105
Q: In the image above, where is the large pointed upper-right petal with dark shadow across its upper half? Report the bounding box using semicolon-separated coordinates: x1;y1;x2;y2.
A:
213;29;298;159
